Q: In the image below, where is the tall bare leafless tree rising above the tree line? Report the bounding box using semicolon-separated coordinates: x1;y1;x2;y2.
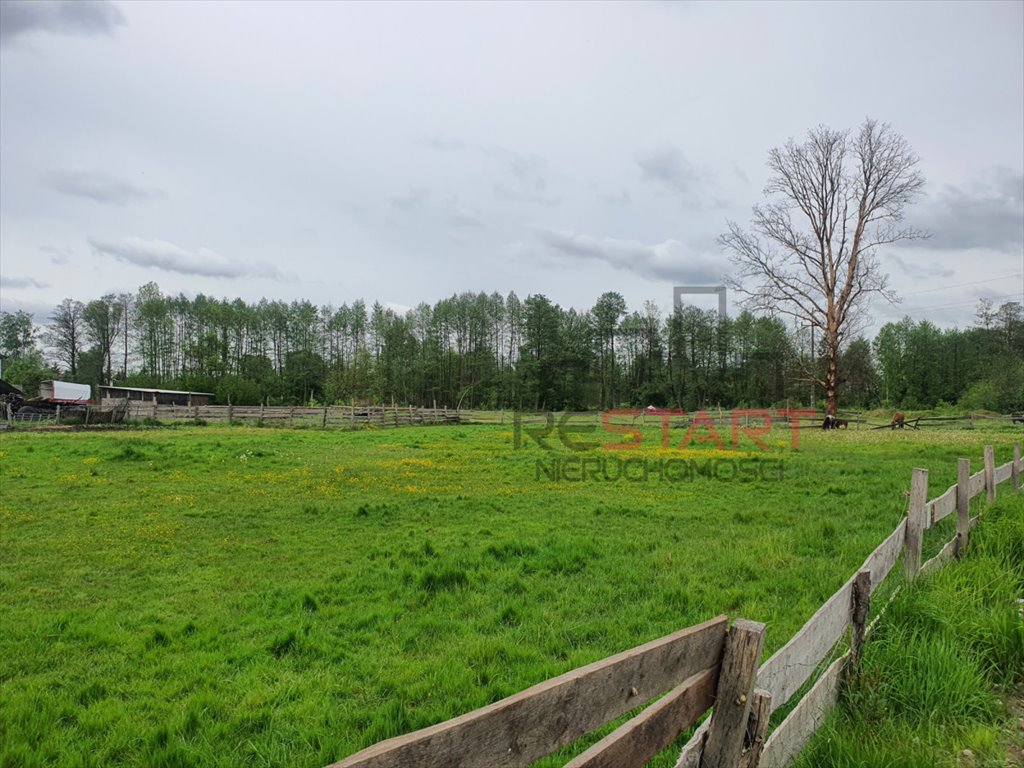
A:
719;120;926;414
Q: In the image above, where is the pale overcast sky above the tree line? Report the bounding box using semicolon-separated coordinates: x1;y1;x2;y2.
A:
0;0;1024;333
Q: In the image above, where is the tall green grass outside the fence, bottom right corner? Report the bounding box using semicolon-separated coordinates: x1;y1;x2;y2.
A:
796;495;1024;768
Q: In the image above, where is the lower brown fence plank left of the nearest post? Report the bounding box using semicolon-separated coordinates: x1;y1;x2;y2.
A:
565;667;719;768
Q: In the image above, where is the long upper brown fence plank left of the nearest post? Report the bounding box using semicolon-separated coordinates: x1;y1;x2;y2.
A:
334;616;727;768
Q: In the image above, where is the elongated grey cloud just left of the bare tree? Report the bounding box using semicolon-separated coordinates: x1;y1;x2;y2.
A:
538;229;726;284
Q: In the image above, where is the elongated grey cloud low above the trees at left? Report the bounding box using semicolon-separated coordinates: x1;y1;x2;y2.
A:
89;238;287;280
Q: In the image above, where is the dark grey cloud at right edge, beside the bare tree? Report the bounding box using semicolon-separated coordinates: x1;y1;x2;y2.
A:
914;168;1024;254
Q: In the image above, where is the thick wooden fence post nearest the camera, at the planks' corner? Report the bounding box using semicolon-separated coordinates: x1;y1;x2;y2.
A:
700;618;765;768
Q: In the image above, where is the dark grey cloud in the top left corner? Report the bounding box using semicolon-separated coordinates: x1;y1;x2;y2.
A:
0;0;125;45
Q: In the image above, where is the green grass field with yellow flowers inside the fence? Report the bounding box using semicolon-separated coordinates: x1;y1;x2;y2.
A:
0;426;1021;767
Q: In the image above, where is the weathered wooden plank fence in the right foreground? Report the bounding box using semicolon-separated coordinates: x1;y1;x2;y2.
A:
331;443;1024;768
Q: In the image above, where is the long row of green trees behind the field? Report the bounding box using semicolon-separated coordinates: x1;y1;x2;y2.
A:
0;283;1024;412
